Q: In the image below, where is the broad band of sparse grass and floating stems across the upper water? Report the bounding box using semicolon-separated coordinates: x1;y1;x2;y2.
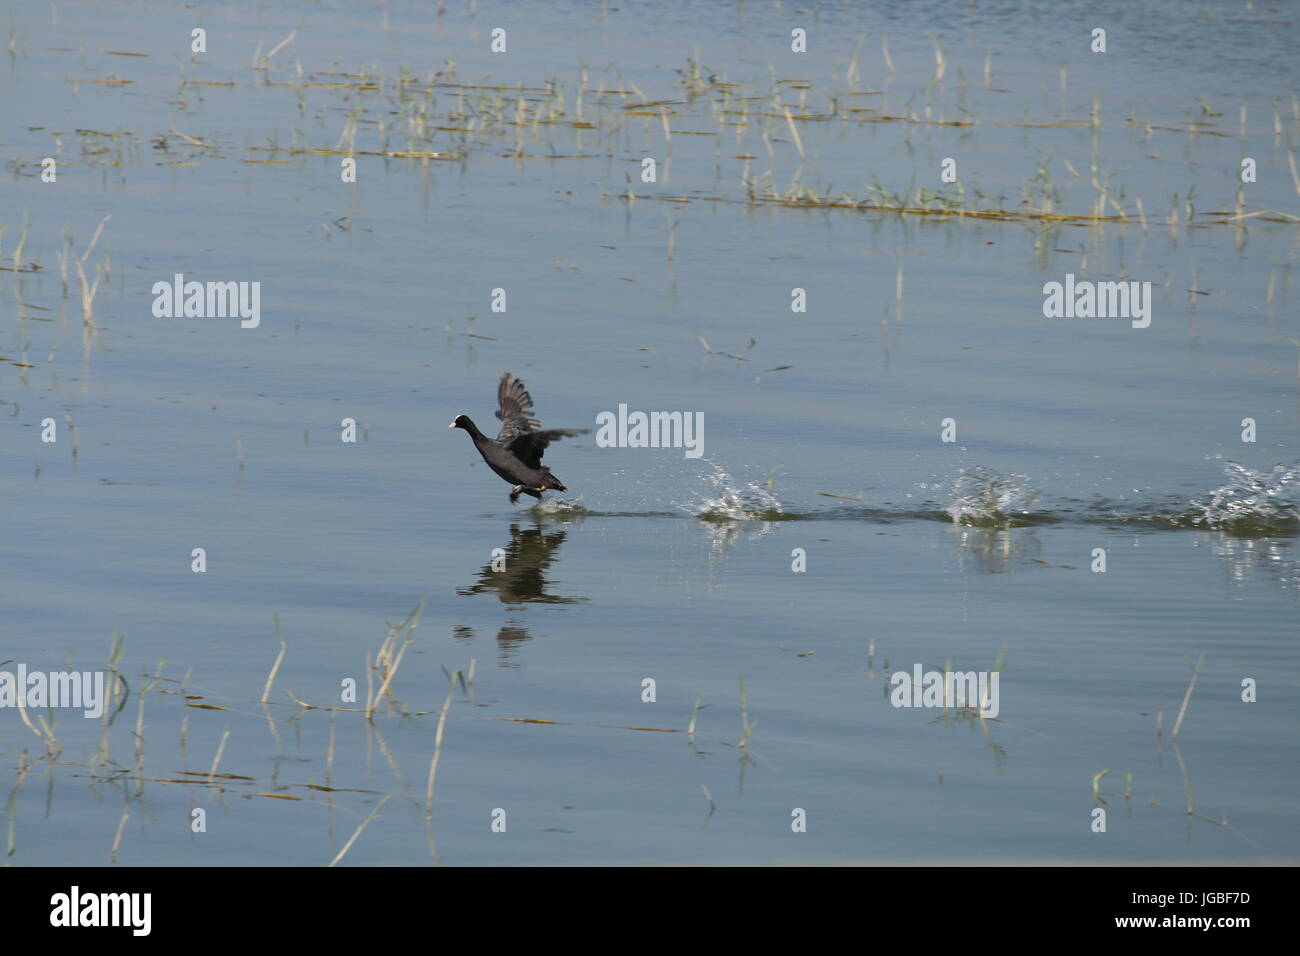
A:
8;40;1300;228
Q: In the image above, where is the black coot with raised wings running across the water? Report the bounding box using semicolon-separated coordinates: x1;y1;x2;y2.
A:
450;372;589;502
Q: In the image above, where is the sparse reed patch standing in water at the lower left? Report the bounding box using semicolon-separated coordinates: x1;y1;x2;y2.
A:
0;616;774;866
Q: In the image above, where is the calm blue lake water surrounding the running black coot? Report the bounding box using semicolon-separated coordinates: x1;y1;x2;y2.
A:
0;3;1300;865
